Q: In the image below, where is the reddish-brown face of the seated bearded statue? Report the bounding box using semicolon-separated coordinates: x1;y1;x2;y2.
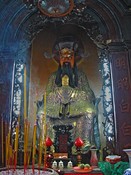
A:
60;48;74;68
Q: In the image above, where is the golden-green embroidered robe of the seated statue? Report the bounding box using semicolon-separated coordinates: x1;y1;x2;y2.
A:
38;71;100;150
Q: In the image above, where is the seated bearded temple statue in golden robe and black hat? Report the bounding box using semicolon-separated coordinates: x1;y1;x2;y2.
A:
37;36;100;152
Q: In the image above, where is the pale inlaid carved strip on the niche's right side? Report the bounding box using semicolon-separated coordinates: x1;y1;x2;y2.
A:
99;49;115;142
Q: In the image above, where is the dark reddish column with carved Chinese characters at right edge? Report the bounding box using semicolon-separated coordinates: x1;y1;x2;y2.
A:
108;42;131;159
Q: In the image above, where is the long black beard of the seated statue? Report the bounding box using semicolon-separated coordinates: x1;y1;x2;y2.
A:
55;62;78;88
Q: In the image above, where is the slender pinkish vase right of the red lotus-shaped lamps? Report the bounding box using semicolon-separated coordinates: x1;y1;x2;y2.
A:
90;149;98;168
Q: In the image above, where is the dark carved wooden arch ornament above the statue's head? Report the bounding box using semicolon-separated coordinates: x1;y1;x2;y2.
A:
25;3;104;46
